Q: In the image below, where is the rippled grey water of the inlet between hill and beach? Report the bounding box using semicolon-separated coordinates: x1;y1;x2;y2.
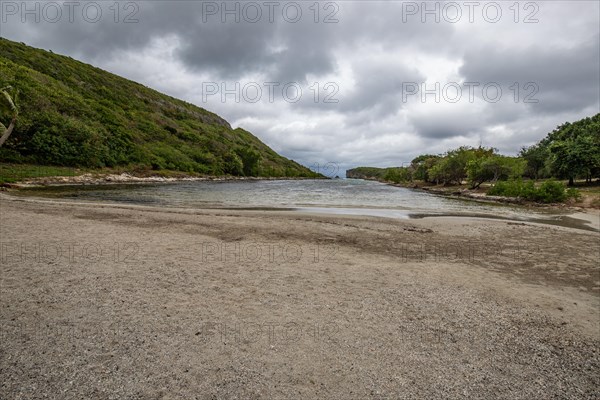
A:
19;179;596;228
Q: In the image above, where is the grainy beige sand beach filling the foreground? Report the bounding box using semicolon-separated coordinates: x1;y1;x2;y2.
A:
0;194;600;399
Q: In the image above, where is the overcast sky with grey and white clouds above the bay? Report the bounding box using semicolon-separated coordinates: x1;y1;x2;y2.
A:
0;1;600;172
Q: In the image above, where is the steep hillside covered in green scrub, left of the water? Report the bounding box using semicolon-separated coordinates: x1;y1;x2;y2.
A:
0;38;320;177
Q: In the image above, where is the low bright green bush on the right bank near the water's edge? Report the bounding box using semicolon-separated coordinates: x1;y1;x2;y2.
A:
487;178;580;203
